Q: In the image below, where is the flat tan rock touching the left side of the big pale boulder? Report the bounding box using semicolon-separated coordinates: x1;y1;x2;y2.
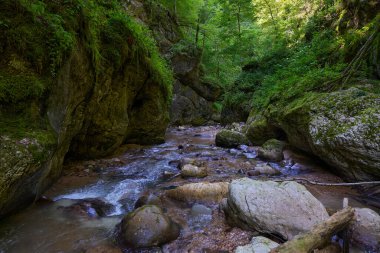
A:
166;182;229;202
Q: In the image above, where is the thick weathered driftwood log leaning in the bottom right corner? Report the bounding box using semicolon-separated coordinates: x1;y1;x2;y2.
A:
271;207;354;253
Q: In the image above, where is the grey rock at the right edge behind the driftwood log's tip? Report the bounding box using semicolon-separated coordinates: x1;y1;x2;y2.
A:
350;208;380;252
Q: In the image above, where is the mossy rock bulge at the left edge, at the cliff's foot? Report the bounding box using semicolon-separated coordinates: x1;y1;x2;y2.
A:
0;131;56;218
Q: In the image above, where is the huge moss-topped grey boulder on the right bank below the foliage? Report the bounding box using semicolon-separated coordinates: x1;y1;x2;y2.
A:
247;88;380;181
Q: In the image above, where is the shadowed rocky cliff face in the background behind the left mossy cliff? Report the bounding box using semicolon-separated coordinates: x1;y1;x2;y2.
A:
126;0;222;125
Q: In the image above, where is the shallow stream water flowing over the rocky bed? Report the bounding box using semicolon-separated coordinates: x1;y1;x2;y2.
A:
0;126;378;253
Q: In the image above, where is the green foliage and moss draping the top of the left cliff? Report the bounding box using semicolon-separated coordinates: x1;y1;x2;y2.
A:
0;0;173;102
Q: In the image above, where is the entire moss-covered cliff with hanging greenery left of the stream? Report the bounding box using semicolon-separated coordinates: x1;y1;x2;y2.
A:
0;0;172;217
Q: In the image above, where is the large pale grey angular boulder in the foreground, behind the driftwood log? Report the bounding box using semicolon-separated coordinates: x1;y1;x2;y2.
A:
222;178;329;240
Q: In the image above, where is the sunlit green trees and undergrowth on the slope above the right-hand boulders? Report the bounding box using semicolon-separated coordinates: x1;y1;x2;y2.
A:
159;0;380;115
